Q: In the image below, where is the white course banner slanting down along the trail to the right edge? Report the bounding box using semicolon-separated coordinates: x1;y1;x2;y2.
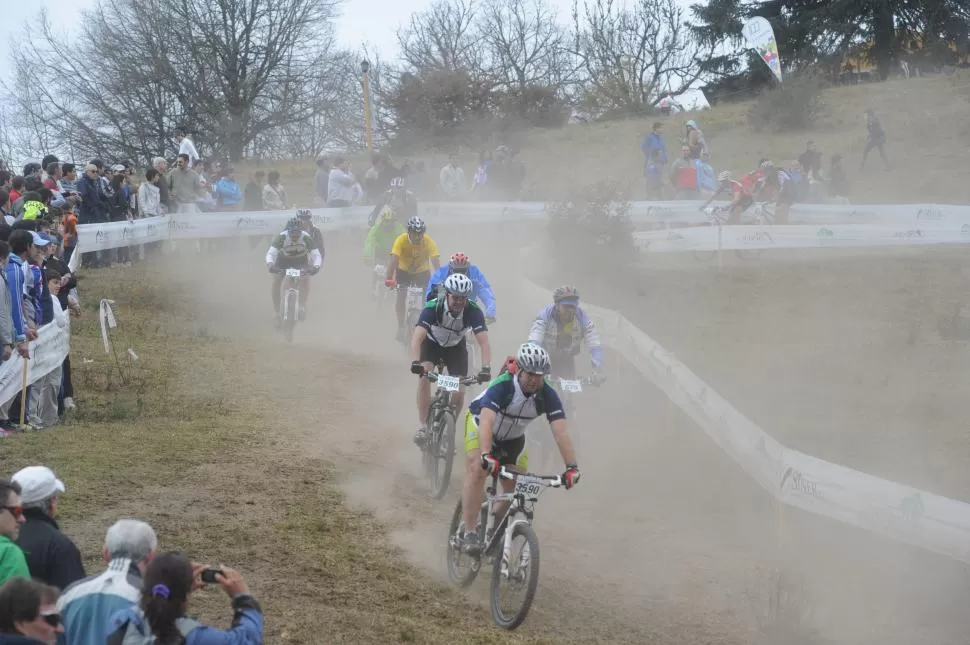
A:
520;245;970;563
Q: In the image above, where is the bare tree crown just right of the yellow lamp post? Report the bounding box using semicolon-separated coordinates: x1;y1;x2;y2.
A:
397;0;482;72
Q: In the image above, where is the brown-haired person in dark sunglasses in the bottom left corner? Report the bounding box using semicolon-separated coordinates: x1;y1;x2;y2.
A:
0;578;64;645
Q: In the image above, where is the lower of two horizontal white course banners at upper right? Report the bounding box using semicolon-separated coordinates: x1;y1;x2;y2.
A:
634;224;970;253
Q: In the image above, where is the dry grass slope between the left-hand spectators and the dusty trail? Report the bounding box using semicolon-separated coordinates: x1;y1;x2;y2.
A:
0;265;584;644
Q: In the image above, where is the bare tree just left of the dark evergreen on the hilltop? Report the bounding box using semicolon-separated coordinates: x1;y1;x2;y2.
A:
573;0;705;111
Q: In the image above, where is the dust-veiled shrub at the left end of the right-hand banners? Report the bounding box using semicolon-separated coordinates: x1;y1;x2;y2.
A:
546;181;637;266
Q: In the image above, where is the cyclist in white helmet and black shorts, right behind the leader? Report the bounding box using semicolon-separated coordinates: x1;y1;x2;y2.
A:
411;273;492;445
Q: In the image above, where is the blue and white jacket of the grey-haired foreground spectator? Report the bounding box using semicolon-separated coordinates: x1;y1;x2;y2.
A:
57;558;141;645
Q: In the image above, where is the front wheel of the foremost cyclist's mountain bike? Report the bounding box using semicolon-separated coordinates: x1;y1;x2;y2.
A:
491;523;539;629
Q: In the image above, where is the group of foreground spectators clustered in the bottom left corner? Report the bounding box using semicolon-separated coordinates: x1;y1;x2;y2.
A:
0;466;263;645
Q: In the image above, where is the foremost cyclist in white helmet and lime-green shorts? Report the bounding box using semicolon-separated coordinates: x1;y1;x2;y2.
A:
461;342;579;553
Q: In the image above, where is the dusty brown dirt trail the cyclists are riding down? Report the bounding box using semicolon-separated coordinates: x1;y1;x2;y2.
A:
166;229;970;643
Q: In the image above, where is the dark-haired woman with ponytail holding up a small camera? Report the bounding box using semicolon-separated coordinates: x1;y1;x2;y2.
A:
107;553;263;645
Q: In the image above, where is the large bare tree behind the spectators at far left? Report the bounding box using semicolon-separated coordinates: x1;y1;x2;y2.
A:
2;0;344;164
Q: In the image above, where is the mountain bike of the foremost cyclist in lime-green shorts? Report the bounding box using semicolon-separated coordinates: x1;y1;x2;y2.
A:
448;466;563;629
